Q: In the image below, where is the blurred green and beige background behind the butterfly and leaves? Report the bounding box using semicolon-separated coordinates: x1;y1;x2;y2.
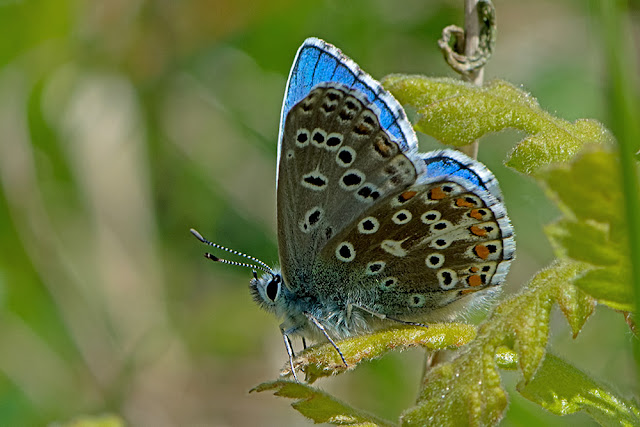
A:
0;0;639;427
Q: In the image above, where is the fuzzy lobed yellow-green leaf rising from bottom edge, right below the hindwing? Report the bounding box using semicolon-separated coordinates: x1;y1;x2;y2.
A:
402;261;593;426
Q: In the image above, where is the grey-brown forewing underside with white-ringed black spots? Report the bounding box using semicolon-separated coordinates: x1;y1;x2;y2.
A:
277;83;422;287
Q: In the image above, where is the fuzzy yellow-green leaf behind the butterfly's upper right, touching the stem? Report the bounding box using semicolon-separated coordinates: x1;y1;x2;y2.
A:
383;74;612;174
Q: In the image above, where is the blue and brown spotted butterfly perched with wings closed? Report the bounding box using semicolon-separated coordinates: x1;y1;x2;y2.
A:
192;38;515;380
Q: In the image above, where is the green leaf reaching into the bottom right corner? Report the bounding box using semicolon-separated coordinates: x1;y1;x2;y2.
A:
518;354;640;426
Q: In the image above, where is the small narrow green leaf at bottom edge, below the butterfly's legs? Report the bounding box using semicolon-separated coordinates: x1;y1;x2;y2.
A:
251;380;394;426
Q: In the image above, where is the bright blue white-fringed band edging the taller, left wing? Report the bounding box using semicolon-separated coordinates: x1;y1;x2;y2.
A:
278;37;418;163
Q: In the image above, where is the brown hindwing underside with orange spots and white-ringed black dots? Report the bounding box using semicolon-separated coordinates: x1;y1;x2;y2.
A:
319;172;513;318
